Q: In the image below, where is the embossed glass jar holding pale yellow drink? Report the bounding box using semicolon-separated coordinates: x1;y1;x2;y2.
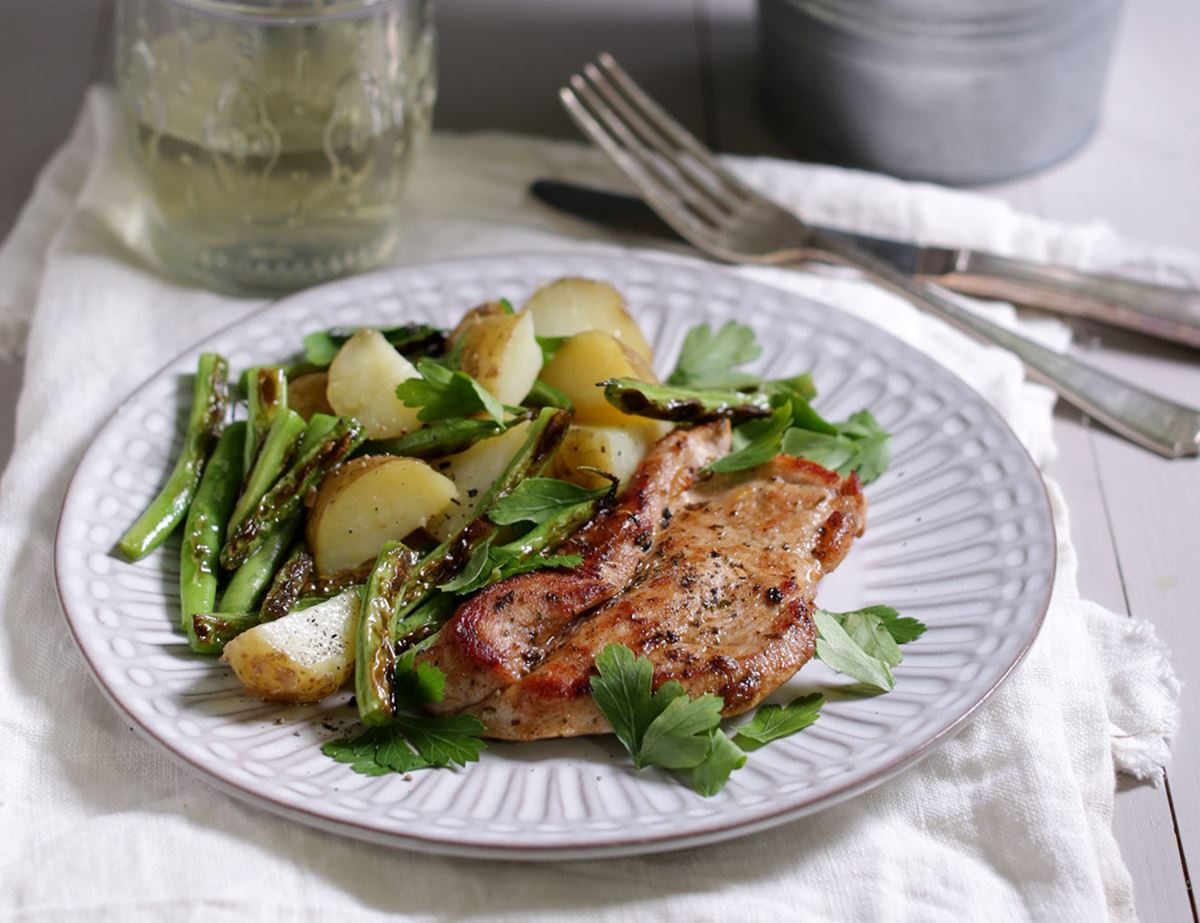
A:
116;0;437;292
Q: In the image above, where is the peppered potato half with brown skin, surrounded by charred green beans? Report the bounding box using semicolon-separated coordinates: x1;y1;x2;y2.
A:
307;455;458;576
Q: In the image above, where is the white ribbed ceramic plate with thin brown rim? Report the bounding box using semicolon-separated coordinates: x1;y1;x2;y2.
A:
56;253;1055;859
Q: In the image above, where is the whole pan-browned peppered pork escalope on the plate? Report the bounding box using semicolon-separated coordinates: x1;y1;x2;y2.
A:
427;424;866;741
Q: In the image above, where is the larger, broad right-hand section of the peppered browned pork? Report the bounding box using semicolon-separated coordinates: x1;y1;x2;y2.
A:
465;456;866;741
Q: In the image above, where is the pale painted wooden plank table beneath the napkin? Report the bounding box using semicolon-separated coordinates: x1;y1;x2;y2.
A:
0;0;1200;923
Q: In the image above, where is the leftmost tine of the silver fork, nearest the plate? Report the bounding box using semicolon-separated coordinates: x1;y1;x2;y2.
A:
558;74;716;247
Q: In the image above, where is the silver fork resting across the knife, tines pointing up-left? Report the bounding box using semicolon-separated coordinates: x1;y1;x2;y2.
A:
559;54;1200;458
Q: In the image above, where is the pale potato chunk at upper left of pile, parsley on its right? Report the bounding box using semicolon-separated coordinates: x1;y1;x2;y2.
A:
325;330;424;439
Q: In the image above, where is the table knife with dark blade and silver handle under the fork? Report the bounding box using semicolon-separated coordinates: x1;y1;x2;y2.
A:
529;179;1200;348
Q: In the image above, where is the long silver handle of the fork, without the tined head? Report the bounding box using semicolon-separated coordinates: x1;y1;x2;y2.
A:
806;232;1200;458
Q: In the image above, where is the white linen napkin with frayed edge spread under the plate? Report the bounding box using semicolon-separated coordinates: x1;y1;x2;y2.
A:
0;89;1180;923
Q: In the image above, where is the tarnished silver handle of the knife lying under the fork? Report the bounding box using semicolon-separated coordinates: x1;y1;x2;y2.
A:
923;250;1200;348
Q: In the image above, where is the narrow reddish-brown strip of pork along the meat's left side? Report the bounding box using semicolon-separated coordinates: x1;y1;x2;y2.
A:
419;421;730;713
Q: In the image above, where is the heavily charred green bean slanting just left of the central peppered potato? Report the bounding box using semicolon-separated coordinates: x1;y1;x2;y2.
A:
221;414;365;570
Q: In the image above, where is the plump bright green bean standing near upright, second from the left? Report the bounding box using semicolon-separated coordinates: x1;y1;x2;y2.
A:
179;422;246;637
